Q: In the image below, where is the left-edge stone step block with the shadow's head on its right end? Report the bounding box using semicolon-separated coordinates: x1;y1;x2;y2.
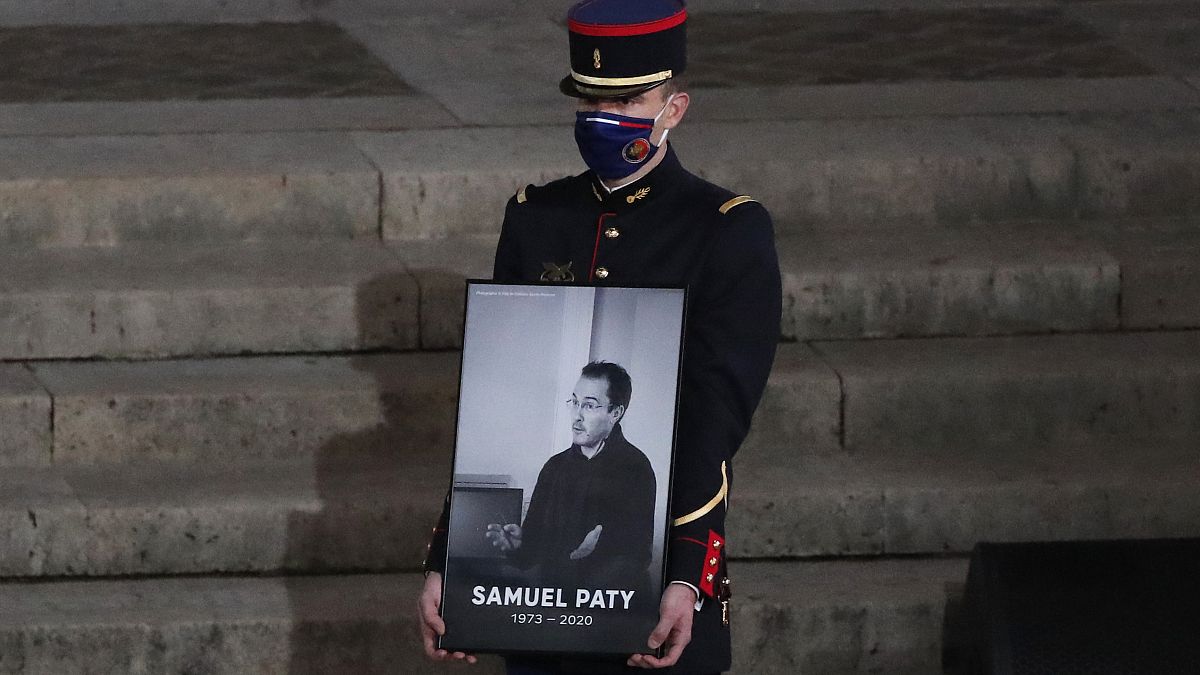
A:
0;241;420;359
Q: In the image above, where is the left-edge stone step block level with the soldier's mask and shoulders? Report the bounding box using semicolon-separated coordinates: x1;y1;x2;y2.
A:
0;132;379;249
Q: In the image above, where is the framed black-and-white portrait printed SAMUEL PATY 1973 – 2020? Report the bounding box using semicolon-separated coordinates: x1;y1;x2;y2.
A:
440;281;686;659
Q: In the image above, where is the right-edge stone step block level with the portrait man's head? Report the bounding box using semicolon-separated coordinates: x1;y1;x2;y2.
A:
806;331;1200;455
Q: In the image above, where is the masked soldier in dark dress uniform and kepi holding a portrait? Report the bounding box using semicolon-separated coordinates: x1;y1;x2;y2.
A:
419;0;781;675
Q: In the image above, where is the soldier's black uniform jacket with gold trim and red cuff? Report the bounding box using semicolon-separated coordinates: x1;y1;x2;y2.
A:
427;145;781;673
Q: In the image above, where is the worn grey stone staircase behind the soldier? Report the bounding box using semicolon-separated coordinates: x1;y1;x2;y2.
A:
0;2;1200;675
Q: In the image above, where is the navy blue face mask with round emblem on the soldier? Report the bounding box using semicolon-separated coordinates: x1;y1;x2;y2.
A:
575;94;674;180
